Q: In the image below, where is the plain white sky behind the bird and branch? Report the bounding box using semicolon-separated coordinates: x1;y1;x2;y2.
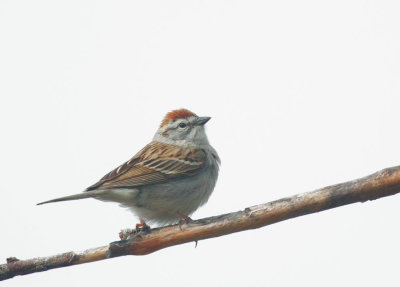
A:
0;0;400;286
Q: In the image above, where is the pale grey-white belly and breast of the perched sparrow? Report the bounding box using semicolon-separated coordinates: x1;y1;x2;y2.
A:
96;150;218;225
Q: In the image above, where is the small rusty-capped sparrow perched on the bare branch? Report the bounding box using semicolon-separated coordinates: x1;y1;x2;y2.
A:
37;109;221;228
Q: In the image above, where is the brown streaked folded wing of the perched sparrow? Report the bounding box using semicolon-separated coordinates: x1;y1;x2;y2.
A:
86;142;206;191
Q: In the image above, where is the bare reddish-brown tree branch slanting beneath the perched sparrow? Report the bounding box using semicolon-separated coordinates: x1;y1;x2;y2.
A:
0;166;400;280
